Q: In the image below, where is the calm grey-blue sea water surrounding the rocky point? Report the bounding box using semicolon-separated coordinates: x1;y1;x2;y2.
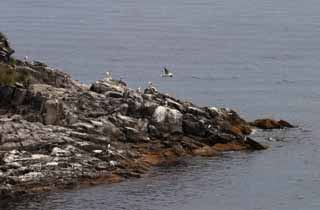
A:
0;0;320;210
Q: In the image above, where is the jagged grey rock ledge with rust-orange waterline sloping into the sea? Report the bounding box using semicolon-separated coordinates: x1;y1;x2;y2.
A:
0;32;291;200
